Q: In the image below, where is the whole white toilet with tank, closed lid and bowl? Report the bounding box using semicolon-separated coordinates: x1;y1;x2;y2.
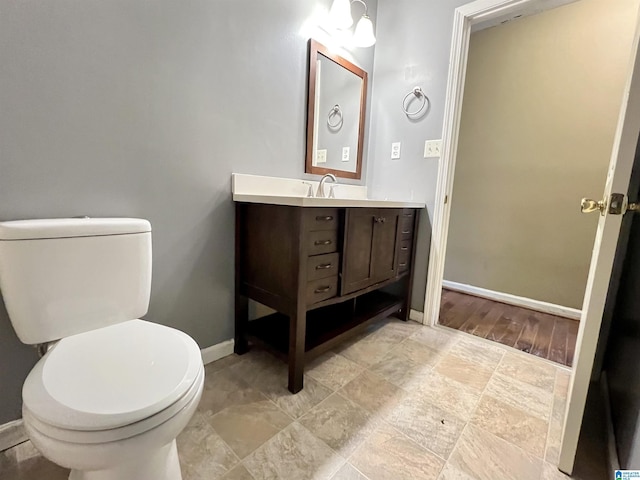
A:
0;218;204;480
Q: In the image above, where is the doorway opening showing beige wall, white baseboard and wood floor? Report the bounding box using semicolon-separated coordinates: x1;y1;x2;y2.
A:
438;0;638;367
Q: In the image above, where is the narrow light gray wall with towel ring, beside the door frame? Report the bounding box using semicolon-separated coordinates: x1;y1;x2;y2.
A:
368;0;476;311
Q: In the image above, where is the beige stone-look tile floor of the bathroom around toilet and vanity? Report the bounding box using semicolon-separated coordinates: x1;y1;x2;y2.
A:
0;319;580;480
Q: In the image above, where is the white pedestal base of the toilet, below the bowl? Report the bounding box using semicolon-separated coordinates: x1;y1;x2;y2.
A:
69;440;182;480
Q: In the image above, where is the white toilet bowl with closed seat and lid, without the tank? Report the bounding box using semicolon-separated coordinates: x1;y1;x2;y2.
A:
23;320;204;480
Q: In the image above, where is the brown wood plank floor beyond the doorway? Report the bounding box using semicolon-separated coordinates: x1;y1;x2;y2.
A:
439;289;579;366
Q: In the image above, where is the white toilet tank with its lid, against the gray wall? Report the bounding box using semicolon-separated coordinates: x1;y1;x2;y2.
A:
0;218;151;344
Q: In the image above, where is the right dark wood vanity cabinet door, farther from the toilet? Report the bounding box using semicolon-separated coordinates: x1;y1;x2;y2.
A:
371;208;401;282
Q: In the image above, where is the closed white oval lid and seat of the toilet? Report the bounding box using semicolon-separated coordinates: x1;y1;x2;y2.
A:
22;320;202;430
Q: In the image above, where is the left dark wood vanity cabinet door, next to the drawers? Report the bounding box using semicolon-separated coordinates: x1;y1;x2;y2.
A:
342;208;378;295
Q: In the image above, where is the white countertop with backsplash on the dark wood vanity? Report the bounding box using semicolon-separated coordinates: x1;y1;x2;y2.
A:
231;173;425;208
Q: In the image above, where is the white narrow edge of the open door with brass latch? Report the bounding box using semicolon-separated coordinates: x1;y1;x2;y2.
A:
559;13;640;474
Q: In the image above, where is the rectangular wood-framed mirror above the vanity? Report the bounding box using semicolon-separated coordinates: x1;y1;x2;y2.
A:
305;39;367;179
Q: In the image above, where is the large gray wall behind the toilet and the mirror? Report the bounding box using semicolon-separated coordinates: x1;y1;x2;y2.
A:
0;0;377;424
